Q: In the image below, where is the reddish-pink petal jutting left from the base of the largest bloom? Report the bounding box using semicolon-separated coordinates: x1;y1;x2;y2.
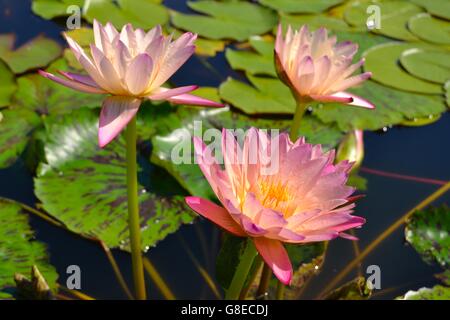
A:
185;197;246;237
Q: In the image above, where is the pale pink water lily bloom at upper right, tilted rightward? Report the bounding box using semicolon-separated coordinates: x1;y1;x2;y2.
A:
275;25;374;108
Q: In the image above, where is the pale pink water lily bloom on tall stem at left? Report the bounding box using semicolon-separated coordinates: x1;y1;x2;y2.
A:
40;21;222;147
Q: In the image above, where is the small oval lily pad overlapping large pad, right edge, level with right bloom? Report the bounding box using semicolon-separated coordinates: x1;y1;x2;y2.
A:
400;48;450;84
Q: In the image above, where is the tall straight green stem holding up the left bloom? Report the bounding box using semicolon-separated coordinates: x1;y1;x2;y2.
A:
125;117;146;300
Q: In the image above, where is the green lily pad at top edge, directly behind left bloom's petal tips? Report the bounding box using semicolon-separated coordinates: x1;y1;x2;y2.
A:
83;0;169;30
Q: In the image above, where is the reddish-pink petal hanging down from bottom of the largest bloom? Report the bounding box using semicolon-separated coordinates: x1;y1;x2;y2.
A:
253;237;292;285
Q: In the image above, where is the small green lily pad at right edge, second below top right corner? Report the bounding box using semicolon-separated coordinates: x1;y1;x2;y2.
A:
408;13;450;45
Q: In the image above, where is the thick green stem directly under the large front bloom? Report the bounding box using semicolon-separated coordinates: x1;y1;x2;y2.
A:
225;239;257;300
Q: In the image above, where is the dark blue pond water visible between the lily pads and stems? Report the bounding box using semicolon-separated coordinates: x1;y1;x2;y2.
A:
0;0;450;299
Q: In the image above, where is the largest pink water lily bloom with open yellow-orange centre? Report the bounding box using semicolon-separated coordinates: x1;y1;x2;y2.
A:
186;128;365;284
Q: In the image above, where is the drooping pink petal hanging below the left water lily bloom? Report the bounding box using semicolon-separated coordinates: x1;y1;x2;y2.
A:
98;96;141;148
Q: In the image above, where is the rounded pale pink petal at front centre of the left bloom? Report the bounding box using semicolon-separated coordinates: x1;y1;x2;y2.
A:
125;53;153;95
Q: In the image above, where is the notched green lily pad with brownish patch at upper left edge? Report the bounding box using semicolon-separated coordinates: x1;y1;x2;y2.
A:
0;34;62;74
